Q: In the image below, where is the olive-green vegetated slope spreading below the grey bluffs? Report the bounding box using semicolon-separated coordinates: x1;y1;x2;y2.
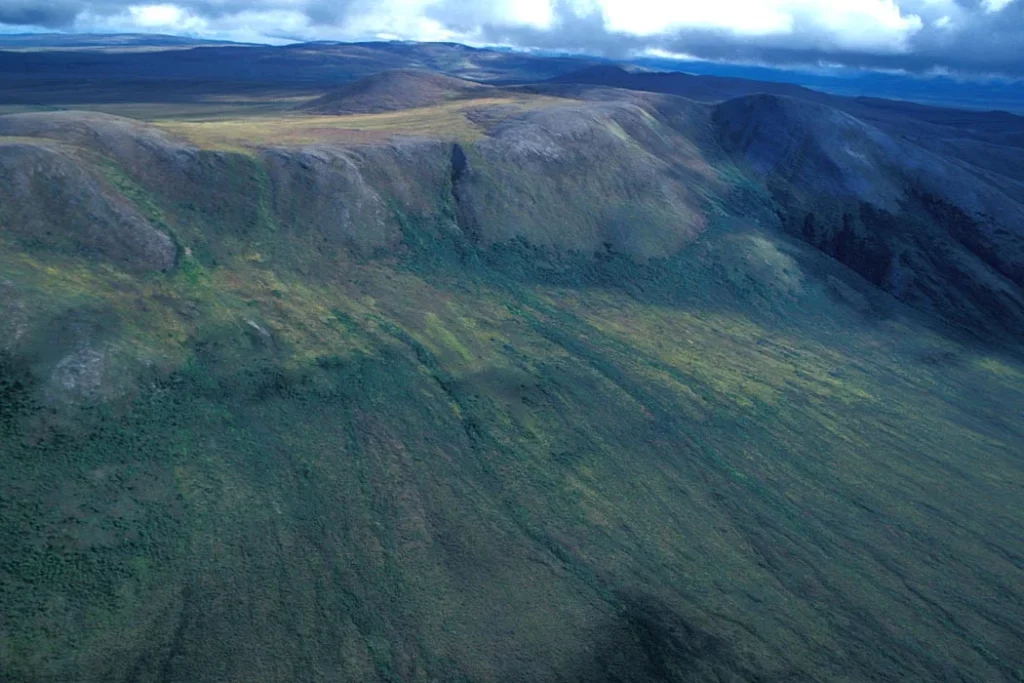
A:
0;104;1024;683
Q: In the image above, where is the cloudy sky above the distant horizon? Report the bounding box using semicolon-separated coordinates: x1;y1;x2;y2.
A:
0;0;1024;77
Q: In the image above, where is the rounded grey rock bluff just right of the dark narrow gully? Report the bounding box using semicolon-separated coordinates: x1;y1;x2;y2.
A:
455;103;705;259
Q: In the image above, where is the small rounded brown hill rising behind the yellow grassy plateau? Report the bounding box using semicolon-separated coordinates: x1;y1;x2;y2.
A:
300;70;489;114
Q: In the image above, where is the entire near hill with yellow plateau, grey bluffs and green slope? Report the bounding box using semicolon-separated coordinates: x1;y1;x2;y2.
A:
0;60;1024;683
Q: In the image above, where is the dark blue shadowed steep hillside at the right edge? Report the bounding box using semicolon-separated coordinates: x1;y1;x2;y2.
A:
714;95;1024;334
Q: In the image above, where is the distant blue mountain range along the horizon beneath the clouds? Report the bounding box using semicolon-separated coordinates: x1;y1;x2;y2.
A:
0;33;1024;113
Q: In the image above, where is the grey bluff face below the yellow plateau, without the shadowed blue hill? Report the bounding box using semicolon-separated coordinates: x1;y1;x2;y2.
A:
0;98;721;267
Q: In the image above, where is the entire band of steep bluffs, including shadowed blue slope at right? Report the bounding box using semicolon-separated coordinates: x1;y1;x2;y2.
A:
8;90;1024;333
